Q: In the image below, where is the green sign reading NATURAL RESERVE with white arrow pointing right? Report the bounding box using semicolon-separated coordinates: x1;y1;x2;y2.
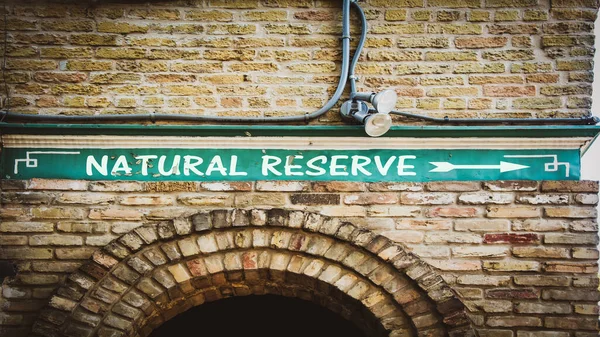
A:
1;147;580;182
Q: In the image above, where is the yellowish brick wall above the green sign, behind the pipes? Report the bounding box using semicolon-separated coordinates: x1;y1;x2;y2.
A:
0;0;597;123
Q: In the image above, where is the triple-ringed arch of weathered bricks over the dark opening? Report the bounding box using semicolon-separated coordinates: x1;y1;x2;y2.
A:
33;209;474;337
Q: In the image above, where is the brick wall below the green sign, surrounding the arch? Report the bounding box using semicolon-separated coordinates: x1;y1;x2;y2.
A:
0;179;600;337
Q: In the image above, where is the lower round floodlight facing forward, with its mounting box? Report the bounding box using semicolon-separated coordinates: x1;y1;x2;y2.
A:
341;101;392;137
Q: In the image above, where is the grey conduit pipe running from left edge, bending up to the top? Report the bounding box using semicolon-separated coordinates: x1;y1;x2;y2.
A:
0;0;354;123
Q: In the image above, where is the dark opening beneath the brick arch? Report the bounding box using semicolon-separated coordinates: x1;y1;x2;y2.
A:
150;295;367;337
